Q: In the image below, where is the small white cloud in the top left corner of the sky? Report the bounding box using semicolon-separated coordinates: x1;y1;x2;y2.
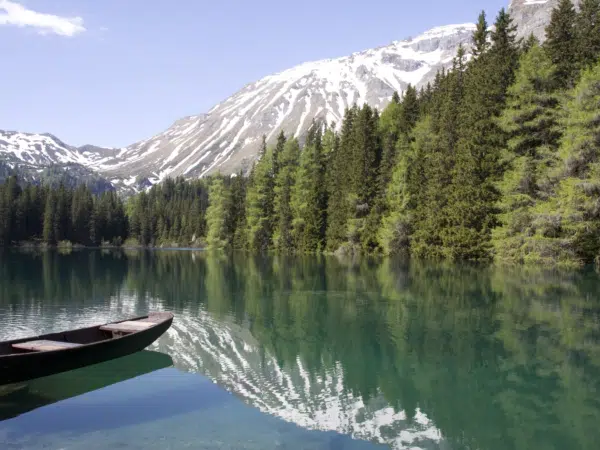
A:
0;0;85;37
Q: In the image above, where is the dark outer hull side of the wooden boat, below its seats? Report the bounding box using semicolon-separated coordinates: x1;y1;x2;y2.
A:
0;315;173;385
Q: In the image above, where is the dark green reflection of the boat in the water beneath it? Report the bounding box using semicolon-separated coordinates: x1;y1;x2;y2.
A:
0;350;173;421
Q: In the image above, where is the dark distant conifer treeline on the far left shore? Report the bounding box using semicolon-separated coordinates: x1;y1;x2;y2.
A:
0;176;128;246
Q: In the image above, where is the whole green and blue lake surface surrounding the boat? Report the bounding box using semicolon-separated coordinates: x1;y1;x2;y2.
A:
0;250;600;450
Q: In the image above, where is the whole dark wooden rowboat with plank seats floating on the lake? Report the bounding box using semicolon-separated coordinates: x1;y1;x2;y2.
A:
0;312;173;385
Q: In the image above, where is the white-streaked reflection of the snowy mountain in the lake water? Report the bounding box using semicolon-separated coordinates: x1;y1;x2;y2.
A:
151;310;447;449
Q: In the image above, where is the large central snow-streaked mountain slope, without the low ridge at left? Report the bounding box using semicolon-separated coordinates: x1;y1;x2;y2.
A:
102;24;474;181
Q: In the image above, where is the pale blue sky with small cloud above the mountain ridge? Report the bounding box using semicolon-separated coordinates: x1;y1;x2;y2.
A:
0;0;508;147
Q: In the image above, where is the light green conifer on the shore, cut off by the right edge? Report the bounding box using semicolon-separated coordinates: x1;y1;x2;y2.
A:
519;60;600;266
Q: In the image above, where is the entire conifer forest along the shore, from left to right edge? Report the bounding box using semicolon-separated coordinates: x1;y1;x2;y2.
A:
0;0;600;266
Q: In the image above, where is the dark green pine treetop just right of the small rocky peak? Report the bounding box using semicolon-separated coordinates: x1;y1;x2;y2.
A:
544;0;578;88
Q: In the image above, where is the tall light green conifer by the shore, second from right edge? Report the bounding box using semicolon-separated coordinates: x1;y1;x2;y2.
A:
493;43;560;261
